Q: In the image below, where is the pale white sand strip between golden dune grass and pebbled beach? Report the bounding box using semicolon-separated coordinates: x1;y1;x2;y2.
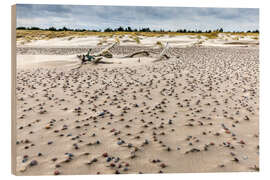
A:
17;33;259;48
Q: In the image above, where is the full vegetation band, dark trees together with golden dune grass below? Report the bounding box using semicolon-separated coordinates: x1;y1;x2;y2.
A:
16;27;259;44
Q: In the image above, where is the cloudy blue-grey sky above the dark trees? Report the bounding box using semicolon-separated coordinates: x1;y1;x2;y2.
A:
17;4;259;31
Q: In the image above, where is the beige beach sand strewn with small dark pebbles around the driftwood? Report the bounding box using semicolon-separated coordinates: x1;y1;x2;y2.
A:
16;35;259;175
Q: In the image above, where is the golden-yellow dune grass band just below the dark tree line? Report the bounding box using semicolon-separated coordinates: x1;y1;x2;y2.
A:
16;30;259;43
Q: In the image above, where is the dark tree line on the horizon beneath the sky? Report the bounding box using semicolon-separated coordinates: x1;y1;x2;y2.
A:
16;26;259;33
